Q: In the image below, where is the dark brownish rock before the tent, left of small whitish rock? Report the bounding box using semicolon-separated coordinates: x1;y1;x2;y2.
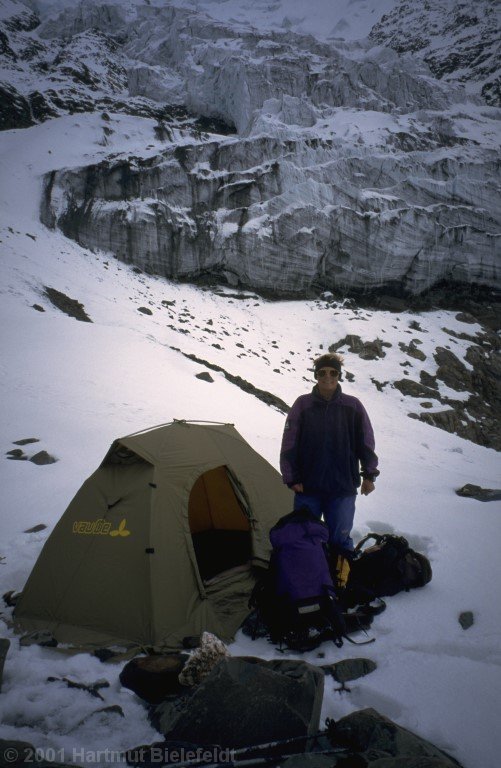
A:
120;653;188;704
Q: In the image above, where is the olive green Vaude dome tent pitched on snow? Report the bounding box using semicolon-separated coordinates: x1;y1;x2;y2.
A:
14;421;292;650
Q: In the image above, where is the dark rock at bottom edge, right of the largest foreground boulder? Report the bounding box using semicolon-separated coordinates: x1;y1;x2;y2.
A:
333;709;459;768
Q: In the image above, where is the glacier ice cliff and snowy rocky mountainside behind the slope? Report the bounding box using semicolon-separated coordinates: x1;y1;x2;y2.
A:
0;0;501;296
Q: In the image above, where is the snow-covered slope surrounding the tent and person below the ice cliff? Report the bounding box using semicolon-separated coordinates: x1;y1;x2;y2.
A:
0;109;501;768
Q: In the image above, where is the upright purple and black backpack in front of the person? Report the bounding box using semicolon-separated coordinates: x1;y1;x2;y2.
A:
249;508;346;651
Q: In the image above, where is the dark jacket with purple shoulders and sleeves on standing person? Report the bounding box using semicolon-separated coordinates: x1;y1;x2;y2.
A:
280;385;379;497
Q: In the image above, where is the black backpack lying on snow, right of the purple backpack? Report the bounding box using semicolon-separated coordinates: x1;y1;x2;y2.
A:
340;533;432;606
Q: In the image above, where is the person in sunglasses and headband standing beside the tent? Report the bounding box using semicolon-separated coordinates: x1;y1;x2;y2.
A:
280;353;379;550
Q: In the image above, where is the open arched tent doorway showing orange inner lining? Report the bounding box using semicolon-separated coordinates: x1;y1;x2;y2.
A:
188;466;252;581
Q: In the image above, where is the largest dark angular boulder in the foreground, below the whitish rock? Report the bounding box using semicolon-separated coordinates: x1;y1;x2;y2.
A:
154;657;324;748
